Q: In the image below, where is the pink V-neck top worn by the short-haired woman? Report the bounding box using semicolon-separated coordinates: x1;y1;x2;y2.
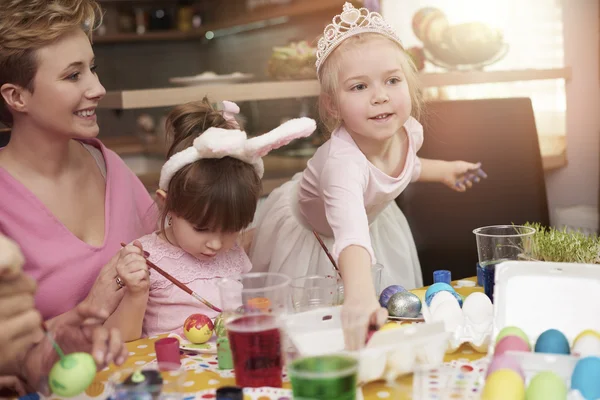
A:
0;139;158;319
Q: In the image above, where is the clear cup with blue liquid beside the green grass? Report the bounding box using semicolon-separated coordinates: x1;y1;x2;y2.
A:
473;225;535;302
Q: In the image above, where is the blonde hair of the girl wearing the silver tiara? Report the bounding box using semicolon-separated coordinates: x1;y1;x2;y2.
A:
319;33;423;133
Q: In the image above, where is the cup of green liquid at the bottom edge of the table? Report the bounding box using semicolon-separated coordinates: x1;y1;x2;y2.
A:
288;354;358;400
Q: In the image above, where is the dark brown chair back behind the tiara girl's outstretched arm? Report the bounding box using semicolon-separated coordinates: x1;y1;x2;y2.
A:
396;98;549;284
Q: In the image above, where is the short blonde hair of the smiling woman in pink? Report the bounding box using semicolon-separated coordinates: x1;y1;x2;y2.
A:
0;0;102;126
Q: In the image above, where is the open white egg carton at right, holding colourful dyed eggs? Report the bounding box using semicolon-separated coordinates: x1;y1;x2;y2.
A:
488;261;600;400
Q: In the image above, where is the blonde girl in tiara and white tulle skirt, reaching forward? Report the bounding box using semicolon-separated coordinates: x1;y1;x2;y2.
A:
250;3;482;348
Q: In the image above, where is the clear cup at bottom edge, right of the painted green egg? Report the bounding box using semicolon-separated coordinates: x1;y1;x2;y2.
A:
109;362;187;400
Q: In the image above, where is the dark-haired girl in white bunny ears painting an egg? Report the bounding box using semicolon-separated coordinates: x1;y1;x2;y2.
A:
111;98;316;340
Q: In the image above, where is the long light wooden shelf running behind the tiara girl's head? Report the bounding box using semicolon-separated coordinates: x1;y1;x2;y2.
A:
99;67;571;110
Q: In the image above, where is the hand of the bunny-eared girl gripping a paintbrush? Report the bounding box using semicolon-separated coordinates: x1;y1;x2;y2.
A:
117;240;150;293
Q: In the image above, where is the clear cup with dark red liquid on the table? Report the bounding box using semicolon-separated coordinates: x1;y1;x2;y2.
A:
218;273;291;387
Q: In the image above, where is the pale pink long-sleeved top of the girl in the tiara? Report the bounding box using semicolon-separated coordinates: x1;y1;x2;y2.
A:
298;117;423;261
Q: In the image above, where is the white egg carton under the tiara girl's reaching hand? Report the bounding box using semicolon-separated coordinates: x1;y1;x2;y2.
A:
283;306;448;383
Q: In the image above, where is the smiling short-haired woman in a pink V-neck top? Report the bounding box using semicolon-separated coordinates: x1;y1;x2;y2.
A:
0;0;157;328
